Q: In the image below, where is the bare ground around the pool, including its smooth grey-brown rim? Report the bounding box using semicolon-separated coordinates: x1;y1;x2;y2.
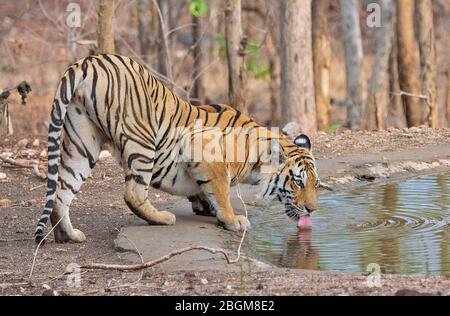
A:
0;130;450;295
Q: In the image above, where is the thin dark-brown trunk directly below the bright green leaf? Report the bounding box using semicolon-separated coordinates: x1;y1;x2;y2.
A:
192;15;206;104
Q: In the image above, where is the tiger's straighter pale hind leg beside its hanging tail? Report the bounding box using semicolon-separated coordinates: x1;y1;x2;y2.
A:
50;105;104;243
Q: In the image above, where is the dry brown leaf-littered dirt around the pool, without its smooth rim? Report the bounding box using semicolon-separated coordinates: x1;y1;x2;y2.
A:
0;128;450;295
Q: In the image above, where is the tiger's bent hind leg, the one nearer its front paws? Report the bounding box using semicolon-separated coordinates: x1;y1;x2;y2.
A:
122;147;176;225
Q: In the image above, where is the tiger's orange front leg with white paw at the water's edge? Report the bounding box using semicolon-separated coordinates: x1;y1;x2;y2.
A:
191;163;250;232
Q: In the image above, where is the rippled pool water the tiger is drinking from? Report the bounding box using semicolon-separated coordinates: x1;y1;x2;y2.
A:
250;175;450;276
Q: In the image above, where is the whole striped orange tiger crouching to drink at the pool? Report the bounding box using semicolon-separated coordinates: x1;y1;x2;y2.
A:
35;54;320;243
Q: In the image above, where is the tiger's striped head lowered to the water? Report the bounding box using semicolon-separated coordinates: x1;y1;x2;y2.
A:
264;135;320;221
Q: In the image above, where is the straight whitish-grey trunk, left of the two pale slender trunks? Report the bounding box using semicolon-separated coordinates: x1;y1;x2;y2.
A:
340;0;365;129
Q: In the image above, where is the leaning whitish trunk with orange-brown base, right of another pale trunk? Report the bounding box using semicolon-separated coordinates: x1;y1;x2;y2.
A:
366;0;395;130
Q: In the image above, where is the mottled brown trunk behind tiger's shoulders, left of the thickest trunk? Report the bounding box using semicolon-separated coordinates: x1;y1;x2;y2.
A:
225;0;247;113
